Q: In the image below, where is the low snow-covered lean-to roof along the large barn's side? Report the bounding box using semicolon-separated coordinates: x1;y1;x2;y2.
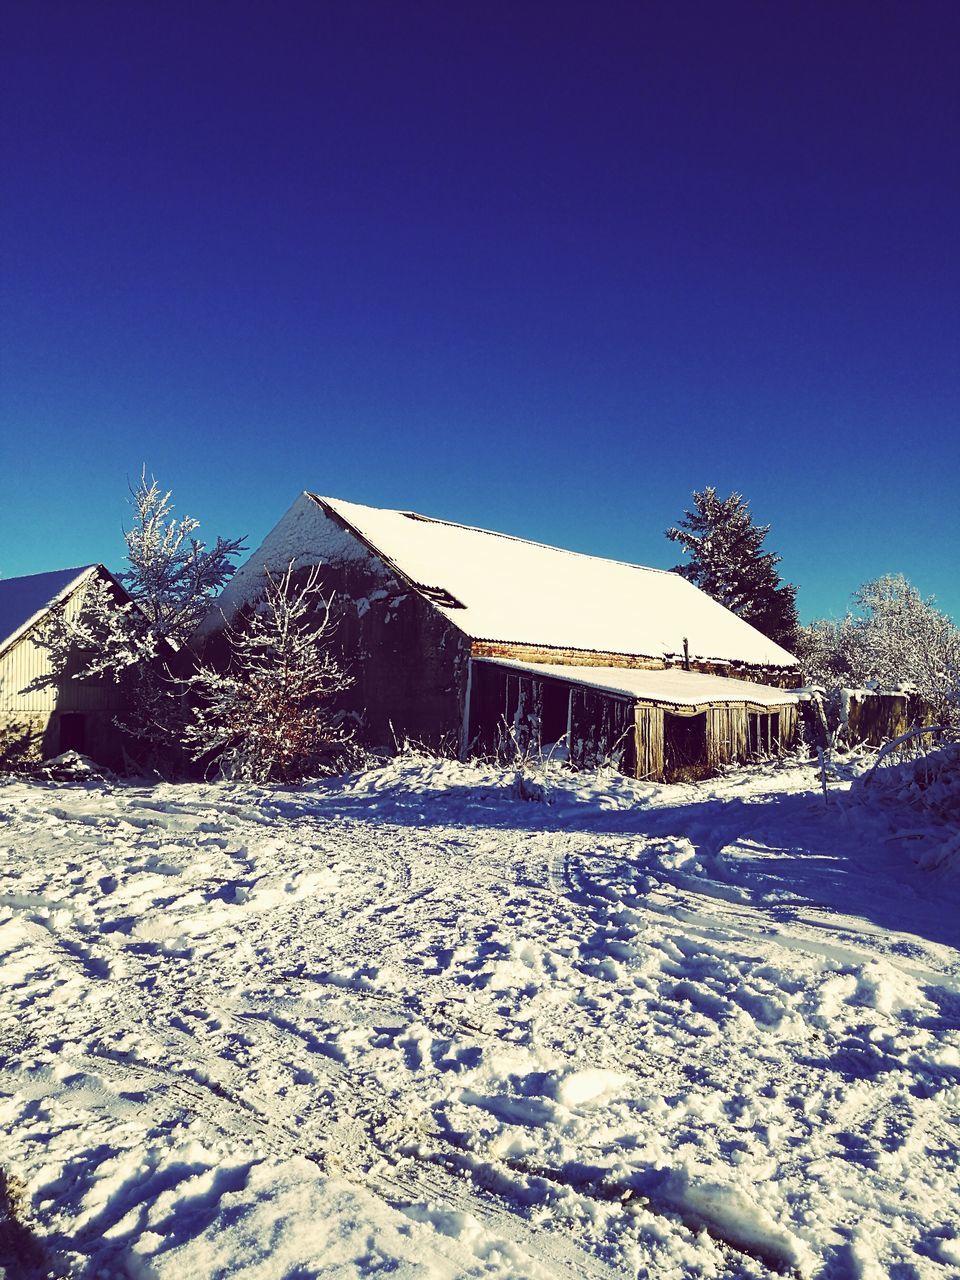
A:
474;658;800;707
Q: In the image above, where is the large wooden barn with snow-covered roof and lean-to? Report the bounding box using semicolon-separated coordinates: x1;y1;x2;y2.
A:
195;493;799;780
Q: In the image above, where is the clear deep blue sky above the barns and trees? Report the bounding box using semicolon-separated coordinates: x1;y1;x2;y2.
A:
0;0;960;618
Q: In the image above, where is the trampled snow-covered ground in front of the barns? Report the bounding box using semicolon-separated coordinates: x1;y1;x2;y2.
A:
0;758;960;1280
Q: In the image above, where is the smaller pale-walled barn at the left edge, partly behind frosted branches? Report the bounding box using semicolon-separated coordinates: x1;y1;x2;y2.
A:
0;564;129;765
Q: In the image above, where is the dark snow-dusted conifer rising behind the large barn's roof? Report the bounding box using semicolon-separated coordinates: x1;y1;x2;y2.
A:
667;485;799;649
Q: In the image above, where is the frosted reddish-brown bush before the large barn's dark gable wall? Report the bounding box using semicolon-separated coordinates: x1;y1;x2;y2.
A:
184;564;356;782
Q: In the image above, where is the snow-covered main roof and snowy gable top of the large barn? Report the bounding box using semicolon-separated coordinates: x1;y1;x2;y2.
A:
207;493;796;667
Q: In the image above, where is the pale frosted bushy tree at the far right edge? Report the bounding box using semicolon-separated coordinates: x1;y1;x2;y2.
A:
797;573;960;723
